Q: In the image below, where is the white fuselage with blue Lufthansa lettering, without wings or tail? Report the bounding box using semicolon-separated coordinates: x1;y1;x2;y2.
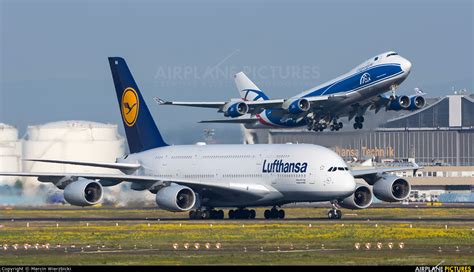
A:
123;144;355;207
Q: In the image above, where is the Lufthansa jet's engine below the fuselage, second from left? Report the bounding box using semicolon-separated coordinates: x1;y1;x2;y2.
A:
156;184;196;212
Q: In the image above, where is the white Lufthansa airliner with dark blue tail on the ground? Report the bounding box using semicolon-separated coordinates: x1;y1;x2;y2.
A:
0;57;418;219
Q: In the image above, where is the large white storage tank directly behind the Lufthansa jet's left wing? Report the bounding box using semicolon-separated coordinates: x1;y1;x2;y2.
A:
23;121;125;197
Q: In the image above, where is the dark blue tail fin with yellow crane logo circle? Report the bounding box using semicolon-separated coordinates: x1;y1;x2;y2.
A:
109;57;167;153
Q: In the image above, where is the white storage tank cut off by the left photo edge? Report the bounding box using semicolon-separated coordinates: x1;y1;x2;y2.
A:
0;123;21;186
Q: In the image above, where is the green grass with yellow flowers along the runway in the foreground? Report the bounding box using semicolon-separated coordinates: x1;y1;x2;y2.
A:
0;208;474;265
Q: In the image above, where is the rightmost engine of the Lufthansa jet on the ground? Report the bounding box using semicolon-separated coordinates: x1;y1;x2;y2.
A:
373;175;411;202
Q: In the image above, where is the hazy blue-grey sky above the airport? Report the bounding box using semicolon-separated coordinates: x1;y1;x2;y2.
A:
0;0;474;144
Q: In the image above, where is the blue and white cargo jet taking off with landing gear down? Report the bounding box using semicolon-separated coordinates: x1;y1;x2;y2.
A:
155;51;425;131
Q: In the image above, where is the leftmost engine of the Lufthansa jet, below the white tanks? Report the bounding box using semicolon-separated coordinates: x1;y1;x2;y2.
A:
64;178;103;206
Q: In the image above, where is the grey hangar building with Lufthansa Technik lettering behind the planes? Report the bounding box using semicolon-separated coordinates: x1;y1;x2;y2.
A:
243;91;474;200
